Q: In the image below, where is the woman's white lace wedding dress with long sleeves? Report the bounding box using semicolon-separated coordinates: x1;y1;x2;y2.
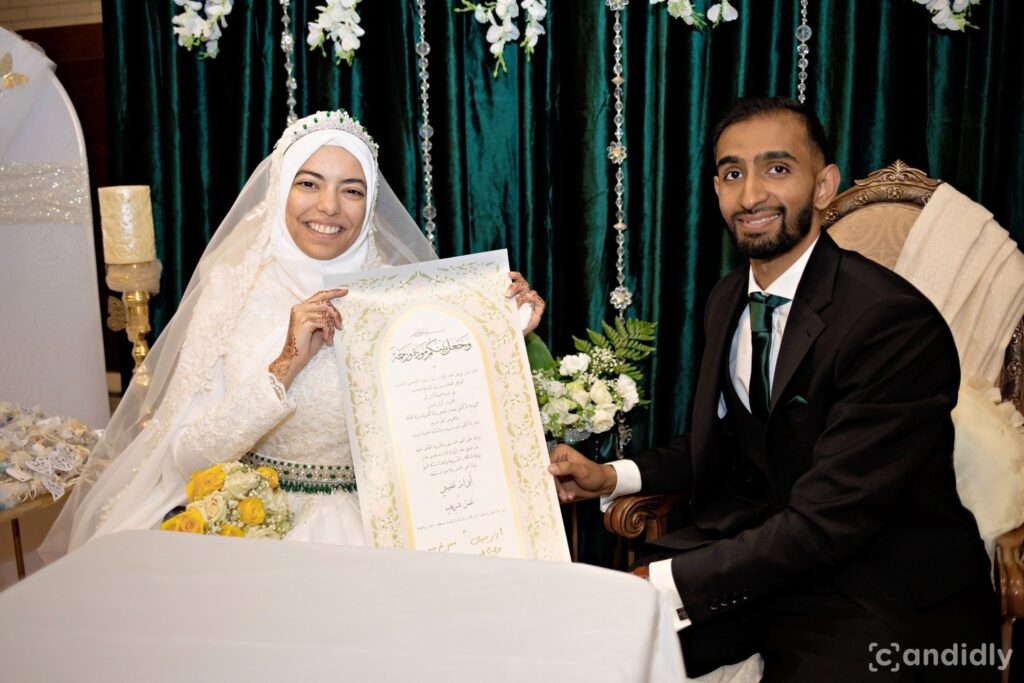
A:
170;264;365;545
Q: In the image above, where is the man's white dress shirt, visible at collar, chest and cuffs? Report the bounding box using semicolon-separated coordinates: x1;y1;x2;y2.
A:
601;240;818;631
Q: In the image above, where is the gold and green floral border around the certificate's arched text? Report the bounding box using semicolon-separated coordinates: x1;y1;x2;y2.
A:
331;251;568;560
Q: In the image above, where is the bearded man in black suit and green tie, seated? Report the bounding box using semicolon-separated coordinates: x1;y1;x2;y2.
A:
550;98;998;682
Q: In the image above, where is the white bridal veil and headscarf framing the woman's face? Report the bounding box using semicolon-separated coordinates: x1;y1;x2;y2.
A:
40;111;436;561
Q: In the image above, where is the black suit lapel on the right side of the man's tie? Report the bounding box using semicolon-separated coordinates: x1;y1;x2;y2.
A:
771;232;842;411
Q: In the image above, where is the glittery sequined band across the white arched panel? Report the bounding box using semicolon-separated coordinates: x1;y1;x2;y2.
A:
0;160;92;225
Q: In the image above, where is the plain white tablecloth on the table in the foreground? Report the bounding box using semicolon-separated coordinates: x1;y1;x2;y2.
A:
0;531;683;683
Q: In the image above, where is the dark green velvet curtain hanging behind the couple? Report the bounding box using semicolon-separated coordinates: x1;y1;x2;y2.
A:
103;0;1024;565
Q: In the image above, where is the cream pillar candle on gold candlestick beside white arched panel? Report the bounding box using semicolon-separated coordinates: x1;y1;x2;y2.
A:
98;185;162;386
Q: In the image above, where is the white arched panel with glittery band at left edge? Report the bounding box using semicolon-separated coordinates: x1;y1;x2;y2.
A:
0;29;110;429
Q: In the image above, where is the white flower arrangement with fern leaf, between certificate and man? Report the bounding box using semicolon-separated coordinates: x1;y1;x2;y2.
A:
534;319;657;442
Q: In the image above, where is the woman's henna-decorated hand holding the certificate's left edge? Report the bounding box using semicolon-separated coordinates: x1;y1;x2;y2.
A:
268;288;348;389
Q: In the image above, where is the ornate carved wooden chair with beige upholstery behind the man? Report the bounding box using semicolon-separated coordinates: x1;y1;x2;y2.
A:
604;161;1024;663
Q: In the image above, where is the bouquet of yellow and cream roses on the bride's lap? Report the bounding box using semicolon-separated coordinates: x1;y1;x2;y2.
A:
160;462;293;539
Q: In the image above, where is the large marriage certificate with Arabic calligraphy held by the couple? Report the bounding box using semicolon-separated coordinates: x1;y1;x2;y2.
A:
326;250;568;561
